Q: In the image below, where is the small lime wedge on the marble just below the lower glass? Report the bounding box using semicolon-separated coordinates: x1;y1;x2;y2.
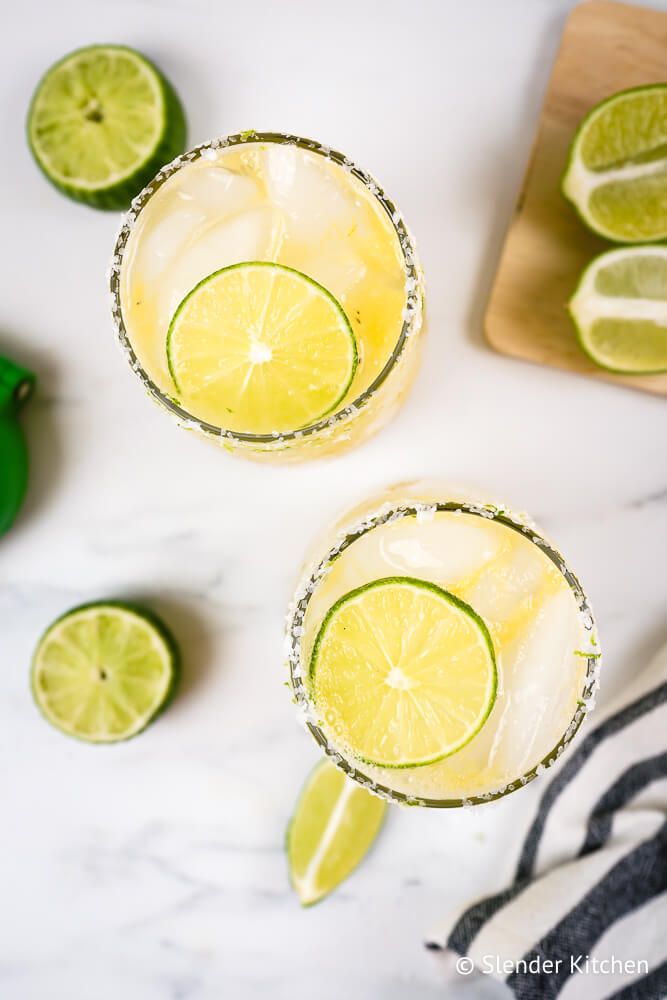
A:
287;759;387;906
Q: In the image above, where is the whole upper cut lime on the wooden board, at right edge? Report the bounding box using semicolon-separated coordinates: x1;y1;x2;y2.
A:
563;83;667;243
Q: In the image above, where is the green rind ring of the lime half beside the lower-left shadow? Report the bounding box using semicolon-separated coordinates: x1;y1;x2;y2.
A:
30;600;181;746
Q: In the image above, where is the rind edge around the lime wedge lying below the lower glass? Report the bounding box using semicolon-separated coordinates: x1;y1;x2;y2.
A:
285;757;387;909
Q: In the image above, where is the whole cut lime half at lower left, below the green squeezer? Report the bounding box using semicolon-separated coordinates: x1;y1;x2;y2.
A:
32;601;179;743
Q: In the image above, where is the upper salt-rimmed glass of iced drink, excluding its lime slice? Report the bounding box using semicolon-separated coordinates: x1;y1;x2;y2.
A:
110;132;423;460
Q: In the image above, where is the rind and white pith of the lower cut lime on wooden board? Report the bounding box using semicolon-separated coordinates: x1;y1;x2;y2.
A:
568;243;667;375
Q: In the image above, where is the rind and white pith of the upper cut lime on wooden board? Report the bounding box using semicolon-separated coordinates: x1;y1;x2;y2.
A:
561;83;667;245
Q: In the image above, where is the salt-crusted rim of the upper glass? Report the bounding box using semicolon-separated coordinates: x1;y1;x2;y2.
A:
109;130;423;445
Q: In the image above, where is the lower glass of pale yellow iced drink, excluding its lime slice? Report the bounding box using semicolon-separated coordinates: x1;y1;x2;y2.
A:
288;484;599;805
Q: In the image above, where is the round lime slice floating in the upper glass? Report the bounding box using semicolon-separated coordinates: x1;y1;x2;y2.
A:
167;261;358;434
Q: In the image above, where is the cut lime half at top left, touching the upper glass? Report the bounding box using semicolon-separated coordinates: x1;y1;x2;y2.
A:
28;45;186;209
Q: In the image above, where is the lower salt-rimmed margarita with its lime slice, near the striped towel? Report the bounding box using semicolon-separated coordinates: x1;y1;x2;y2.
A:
287;484;599;806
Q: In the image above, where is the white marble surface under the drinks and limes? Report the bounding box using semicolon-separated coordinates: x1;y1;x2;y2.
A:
0;0;667;1000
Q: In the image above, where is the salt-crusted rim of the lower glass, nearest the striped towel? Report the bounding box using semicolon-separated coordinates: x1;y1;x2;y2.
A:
287;500;601;809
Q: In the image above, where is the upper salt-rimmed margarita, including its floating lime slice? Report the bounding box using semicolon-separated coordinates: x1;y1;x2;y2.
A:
111;132;422;458
